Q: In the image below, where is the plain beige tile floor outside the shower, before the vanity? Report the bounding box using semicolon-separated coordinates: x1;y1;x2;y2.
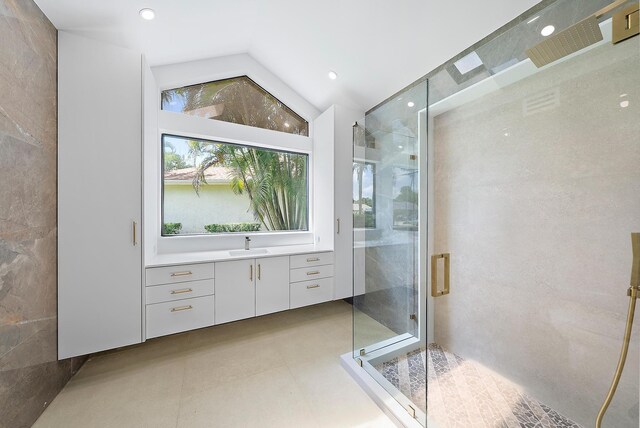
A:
34;301;394;428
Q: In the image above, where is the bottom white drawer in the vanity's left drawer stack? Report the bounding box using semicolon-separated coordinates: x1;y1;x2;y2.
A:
147;296;213;339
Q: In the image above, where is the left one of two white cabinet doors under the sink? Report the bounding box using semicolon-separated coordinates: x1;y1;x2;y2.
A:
214;259;256;324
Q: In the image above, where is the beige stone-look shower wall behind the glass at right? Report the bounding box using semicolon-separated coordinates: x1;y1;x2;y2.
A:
433;37;640;428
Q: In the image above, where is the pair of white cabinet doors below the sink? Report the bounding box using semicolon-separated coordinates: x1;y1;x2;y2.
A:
215;256;289;324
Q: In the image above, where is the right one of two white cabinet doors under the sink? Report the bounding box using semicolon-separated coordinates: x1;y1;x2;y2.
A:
256;256;289;315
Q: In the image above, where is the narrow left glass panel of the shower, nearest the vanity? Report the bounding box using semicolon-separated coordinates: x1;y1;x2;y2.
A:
353;80;427;424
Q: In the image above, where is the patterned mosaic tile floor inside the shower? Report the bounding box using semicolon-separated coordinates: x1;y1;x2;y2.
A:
376;344;582;428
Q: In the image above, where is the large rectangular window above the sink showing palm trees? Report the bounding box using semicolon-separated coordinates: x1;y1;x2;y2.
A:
162;135;309;236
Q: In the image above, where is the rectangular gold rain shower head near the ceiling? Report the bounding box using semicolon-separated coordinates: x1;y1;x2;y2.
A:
527;15;603;67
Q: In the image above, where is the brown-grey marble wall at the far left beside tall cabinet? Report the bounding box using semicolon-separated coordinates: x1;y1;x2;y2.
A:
0;0;84;428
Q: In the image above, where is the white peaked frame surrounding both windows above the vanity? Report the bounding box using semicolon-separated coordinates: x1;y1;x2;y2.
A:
144;55;319;257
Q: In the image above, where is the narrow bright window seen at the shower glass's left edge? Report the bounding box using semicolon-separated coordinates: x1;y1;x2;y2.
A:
353;161;376;229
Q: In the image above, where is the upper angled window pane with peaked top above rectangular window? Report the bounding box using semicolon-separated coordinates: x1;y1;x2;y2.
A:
161;76;309;136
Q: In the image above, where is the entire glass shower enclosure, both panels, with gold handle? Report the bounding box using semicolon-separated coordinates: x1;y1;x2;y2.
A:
353;0;640;428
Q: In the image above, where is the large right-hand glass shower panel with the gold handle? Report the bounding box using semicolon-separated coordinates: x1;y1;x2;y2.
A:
427;0;640;428
